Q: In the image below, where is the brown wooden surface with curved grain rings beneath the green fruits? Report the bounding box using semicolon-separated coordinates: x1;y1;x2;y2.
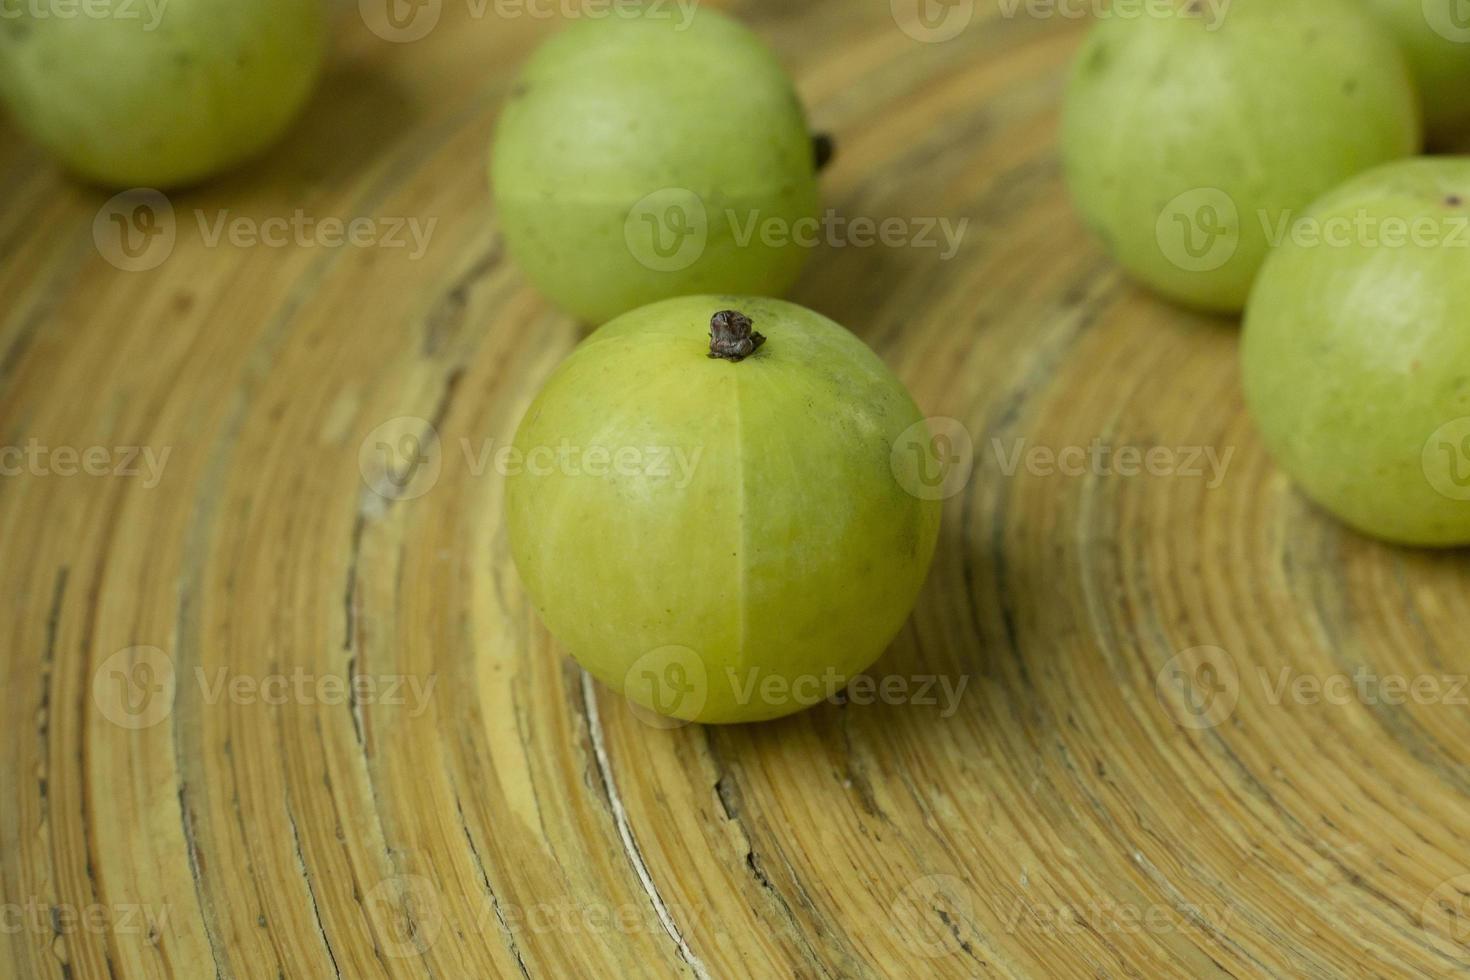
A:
0;0;1470;979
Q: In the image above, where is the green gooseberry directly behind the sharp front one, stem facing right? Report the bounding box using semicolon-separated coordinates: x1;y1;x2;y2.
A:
491;4;820;323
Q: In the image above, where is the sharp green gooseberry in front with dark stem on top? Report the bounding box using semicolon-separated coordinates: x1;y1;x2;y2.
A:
507;295;941;723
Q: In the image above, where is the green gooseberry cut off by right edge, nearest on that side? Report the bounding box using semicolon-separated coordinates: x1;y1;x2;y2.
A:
1244;157;1470;547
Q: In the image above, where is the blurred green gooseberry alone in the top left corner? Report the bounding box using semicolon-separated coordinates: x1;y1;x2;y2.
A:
0;0;326;190
